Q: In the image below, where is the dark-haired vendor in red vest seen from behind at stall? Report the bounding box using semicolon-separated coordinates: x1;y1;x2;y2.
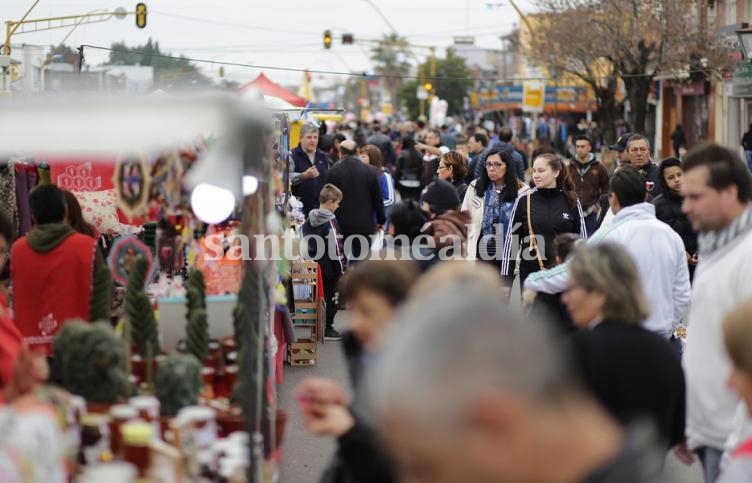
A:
11;185;96;355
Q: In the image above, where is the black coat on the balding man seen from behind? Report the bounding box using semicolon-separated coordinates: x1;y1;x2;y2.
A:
326;156;386;236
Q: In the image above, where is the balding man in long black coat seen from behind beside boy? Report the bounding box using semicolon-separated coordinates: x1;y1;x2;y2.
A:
326;139;386;264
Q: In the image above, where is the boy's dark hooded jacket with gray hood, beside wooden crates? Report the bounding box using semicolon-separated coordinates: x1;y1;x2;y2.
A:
300;208;345;279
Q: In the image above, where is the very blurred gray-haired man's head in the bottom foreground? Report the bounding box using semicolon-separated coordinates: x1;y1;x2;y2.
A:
367;287;667;483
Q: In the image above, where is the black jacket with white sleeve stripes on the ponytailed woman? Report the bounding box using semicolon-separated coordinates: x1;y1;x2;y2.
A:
501;188;586;286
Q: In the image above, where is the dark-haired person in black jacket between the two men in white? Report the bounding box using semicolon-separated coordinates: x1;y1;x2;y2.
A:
652;158;697;280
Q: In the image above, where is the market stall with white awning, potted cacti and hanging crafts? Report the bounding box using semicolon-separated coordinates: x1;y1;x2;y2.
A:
0;95;291;482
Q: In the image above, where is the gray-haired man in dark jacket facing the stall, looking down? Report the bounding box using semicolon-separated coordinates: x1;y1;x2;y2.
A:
289;123;329;218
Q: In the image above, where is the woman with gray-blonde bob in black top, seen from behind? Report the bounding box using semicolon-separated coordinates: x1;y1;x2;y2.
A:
562;243;686;449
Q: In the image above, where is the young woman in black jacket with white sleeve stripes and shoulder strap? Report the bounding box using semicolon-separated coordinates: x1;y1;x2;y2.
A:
501;154;587;287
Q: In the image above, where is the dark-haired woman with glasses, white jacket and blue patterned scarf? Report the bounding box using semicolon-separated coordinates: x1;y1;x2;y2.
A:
462;145;529;268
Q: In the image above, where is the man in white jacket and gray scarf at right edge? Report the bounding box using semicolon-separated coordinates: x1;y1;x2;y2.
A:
678;144;752;482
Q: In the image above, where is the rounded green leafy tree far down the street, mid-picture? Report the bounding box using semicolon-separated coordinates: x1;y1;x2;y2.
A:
402;49;473;119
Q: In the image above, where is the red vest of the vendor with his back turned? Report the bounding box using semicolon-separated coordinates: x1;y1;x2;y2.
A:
11;233;96;355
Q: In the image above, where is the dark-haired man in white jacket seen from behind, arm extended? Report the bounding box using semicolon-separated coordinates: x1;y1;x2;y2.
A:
524;167;690;345
